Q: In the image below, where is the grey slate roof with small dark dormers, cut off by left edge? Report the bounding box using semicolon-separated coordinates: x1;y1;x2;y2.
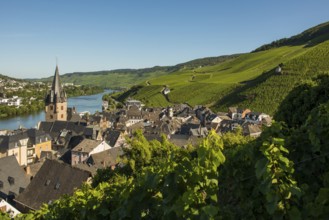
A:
0;156;30;201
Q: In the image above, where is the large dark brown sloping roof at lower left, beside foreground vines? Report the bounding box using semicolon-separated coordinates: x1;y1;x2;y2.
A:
14;159;91;213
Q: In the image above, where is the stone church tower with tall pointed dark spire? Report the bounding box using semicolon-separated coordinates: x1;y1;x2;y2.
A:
45;65;67;121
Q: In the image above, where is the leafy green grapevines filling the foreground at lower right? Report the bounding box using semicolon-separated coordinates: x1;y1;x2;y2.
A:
18;74;329;219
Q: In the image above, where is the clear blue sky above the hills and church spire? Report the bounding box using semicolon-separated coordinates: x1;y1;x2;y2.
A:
0;0;329;78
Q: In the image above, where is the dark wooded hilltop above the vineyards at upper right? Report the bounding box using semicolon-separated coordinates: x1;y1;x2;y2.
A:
253;22;329;52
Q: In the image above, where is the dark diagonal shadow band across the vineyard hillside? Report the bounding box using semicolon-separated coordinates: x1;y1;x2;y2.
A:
213;69;278;109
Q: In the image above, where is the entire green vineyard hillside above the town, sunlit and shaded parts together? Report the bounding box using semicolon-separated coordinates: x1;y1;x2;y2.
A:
117;23;329;115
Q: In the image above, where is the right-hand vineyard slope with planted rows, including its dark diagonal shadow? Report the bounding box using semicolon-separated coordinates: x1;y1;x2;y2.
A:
215;41;329;114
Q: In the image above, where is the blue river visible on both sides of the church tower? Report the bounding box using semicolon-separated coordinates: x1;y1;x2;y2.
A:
0;90;112;130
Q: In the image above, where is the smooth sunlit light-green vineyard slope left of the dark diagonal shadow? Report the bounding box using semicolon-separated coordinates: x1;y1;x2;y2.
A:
120;46;309;109
